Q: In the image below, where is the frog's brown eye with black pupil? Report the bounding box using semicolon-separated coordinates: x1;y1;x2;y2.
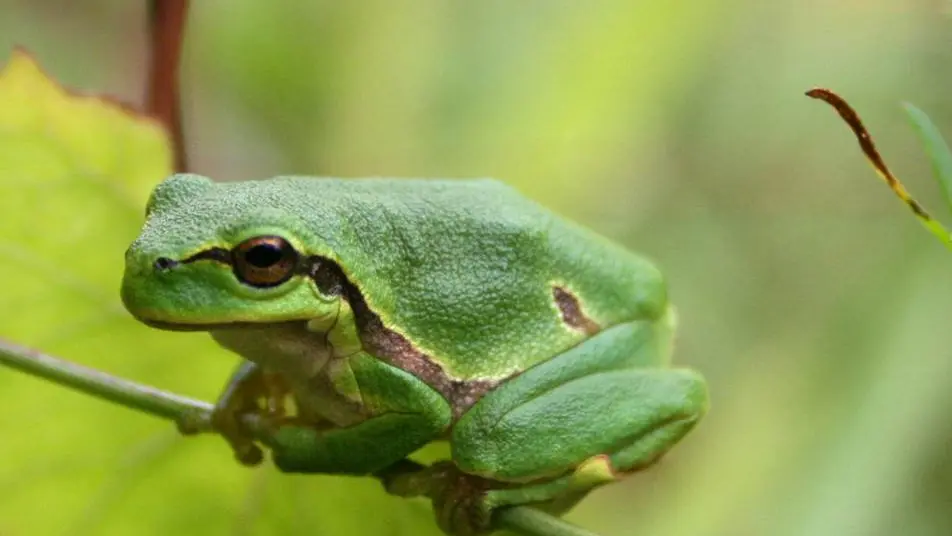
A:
231;236;298;287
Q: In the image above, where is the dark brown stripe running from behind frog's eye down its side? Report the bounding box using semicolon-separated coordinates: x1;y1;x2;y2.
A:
306;257;499;417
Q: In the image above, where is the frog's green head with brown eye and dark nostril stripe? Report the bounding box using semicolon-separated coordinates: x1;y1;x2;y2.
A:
122;174;339;330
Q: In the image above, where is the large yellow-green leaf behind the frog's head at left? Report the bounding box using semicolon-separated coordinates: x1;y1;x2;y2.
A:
0;51;436;535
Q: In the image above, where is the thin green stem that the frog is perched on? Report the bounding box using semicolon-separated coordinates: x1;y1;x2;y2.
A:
0;339;595;536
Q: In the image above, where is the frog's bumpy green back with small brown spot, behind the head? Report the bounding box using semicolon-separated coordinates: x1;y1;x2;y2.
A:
238;177;666;379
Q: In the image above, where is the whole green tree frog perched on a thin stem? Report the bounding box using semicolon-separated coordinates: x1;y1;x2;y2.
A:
122;174;708;534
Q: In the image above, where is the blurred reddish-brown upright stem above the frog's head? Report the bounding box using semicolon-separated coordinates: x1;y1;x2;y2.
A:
146;0;188;172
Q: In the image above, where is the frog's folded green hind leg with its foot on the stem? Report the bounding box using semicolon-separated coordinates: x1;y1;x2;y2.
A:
416;323;707;534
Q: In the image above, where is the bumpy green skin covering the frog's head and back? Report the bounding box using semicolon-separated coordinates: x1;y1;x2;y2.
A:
125;173;667;379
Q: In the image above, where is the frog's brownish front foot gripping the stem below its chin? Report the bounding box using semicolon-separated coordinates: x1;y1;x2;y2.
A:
194;362;289;466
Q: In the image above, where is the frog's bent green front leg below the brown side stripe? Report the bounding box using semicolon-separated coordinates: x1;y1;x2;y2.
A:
266;352;452;475
